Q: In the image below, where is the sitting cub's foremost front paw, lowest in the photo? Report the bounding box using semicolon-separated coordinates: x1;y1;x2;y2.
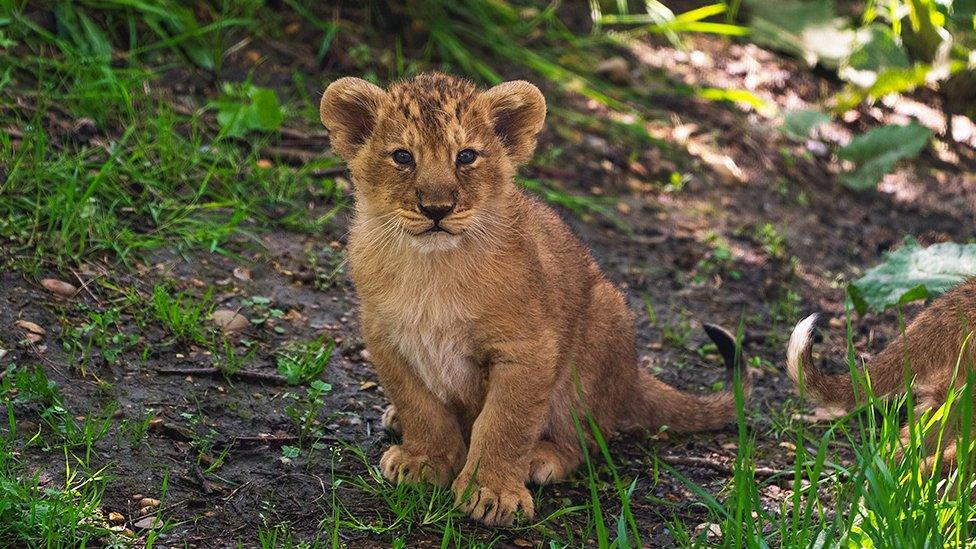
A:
451;474;535;526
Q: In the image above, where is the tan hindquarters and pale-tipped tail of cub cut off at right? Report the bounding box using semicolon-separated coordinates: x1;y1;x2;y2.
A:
786;278;976;465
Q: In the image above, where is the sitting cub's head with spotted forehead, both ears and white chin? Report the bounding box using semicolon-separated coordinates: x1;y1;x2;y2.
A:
320;73;546;250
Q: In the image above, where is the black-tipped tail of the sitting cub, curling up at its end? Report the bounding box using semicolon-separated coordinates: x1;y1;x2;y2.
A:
632;324;752;432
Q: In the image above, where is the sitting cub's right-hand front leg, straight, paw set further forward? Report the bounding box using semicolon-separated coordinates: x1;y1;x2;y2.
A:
452;337;556;525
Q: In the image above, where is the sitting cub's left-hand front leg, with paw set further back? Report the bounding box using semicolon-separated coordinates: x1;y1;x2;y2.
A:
366;338;466;486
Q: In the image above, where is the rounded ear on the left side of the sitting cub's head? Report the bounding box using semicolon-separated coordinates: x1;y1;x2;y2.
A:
319;77;386;161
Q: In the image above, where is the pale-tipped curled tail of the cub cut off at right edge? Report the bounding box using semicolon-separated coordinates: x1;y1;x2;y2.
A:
786;314;904;409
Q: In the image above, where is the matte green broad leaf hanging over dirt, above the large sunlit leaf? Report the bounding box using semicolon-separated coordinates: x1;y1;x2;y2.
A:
837;121;932;191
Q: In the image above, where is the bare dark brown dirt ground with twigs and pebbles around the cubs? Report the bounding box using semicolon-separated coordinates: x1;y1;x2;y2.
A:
0;10;976;547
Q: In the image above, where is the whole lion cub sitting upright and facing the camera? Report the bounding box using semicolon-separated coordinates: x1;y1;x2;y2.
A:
321;73;748;524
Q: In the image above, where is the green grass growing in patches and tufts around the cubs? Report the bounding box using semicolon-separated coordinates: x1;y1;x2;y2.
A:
0;0;976;548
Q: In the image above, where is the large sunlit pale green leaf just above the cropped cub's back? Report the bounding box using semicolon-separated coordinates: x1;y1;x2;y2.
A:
847;238;976;314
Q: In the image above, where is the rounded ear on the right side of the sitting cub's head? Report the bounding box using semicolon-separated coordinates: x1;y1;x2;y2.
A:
478;80;546;165
